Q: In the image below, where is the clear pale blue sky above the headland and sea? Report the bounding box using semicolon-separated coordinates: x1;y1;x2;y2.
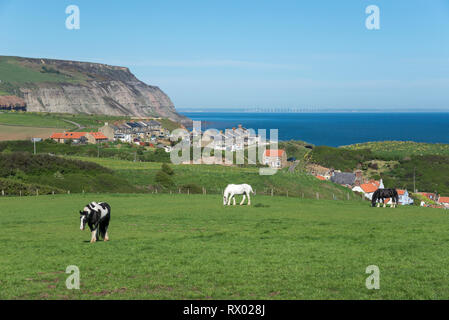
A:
0;0;449;111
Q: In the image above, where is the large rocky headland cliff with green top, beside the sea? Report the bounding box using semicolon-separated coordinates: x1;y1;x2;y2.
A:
0;57;188;122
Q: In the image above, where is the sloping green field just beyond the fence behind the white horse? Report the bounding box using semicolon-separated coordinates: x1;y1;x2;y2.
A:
70;157;359;200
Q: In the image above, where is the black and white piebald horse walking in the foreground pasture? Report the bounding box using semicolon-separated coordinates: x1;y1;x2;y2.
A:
80;202;111;243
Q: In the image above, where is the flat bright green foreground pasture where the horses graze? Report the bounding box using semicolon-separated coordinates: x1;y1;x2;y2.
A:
0;194;449;299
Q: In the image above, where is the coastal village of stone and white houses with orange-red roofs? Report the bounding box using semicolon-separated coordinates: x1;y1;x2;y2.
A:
51;119;449;209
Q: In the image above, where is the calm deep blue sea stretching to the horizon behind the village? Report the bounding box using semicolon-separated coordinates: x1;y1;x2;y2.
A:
183;112;449;147
